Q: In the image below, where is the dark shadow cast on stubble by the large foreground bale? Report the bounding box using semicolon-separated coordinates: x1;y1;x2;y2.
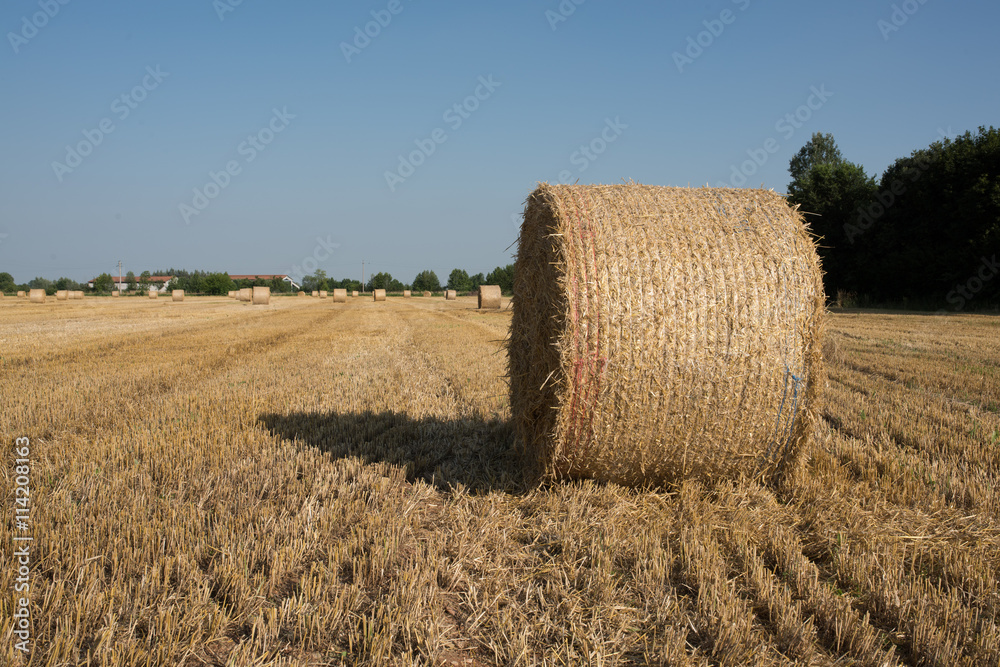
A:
259;411;537;493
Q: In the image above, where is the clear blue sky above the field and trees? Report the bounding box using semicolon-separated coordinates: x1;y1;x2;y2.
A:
0;0;1000;282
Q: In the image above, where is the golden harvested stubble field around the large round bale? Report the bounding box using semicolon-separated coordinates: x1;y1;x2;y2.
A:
0;297;1000;667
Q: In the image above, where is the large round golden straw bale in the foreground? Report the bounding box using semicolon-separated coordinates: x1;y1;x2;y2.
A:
508;184;824;485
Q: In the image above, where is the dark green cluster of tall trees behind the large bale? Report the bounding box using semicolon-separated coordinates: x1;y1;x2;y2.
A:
788;127;1000;311
